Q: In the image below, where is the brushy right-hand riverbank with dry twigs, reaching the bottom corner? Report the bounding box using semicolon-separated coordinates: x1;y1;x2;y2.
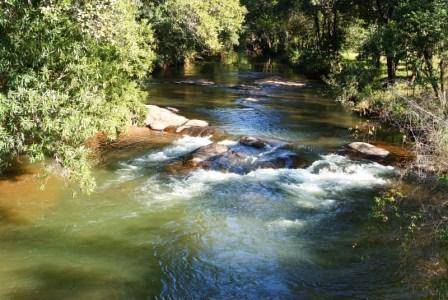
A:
327;71;448;299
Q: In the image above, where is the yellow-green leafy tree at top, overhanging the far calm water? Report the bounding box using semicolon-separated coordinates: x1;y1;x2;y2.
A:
143;0;246;65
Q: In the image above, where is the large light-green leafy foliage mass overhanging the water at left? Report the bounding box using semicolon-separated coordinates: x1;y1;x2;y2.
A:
0;0;154;191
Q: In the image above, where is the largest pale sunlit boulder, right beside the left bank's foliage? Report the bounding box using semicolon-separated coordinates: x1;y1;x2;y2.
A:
145;105;188;131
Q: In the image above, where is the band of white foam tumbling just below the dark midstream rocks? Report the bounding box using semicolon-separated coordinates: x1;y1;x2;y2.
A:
142;155;394;209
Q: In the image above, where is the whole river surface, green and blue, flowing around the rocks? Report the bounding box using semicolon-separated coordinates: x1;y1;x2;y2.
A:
0;62;415;299
